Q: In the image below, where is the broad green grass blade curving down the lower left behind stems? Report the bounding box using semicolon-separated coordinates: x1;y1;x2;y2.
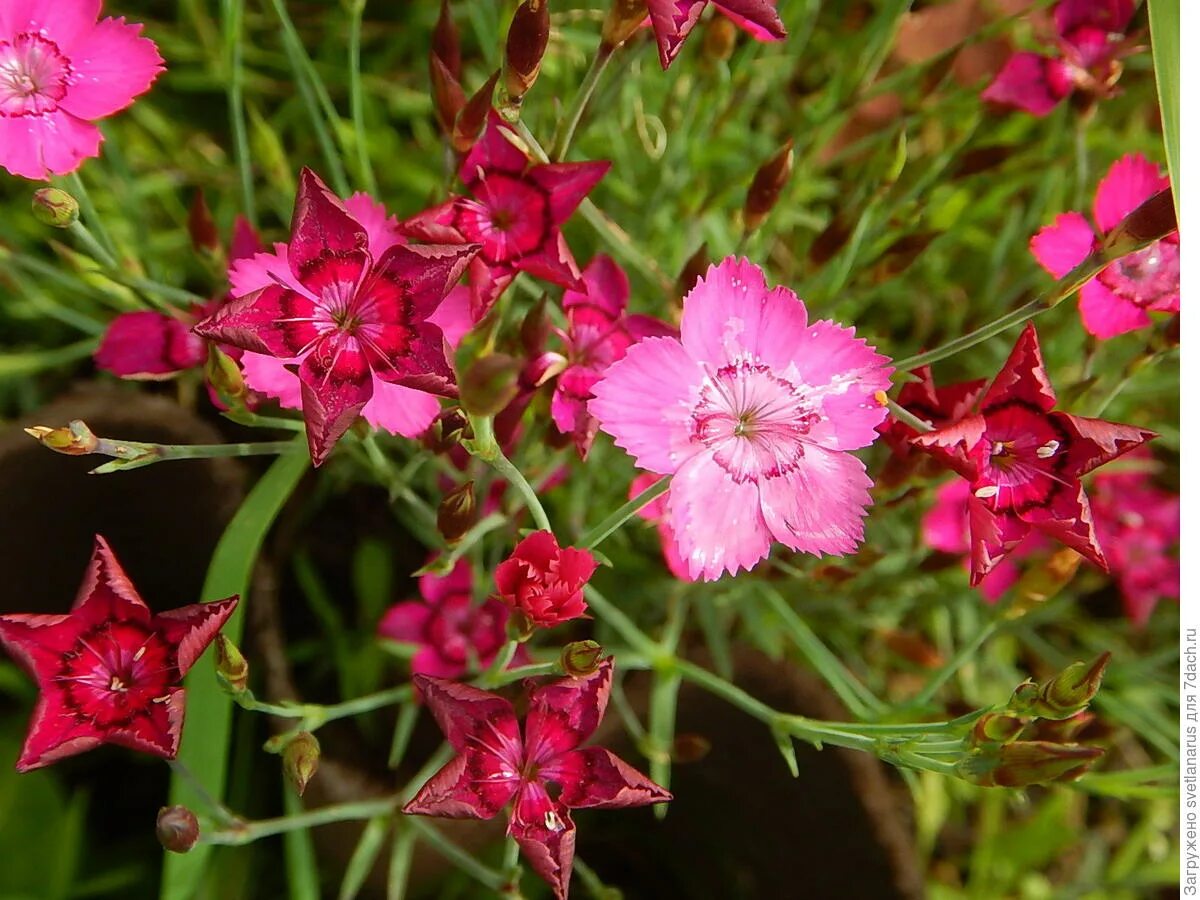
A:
161;446;308;900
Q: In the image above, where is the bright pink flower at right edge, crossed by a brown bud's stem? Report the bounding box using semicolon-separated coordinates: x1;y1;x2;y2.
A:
1030;154;1180;337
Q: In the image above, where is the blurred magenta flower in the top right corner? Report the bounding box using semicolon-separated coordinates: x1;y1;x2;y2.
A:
982;0;1134;116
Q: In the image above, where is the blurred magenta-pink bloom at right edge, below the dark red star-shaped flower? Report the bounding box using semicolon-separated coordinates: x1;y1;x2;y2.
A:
1092;472;1180;628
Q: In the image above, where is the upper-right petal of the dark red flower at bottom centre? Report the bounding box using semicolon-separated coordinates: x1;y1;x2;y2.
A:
526;656;612;766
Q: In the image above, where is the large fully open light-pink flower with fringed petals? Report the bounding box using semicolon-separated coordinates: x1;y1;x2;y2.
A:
588;257;892;580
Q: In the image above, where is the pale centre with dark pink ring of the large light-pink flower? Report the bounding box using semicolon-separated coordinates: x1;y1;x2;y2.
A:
691;361;821;484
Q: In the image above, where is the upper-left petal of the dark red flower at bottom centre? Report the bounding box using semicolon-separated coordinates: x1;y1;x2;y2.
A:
413;674;521;768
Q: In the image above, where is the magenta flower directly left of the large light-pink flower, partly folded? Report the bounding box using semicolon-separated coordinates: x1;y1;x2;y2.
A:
550;256;674;458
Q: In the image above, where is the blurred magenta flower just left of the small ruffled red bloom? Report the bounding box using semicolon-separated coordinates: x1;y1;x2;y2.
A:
378;559;518;678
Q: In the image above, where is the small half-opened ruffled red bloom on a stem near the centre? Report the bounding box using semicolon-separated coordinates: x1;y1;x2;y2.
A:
496;532;596;628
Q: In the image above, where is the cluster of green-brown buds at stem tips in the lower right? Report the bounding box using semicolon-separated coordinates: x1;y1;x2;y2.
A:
955;653;1111;787
